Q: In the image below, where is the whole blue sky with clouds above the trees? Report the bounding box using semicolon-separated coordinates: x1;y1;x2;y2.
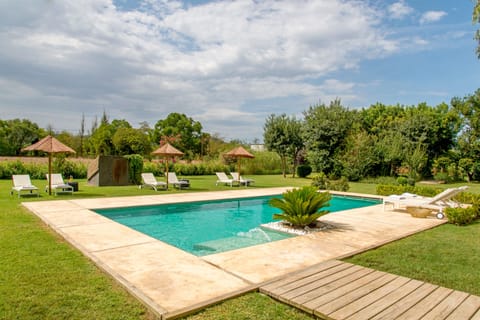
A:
0;0;480;142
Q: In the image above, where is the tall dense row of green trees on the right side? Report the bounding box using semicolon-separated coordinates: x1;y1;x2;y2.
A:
264;89;480;183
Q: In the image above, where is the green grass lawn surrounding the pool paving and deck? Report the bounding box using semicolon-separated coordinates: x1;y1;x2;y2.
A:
0;176;480;319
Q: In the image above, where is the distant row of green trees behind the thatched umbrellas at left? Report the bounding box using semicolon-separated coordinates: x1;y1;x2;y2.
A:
0;112;244;160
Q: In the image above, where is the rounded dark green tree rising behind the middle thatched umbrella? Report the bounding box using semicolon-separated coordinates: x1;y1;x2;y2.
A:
153;112;202;158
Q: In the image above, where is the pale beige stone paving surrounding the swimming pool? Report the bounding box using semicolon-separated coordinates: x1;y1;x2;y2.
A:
23;188;446;319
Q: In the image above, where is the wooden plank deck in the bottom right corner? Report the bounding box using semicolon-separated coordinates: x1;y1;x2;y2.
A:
260;260;480;320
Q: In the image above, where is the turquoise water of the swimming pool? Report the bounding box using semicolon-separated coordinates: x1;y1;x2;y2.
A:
95;196;379;256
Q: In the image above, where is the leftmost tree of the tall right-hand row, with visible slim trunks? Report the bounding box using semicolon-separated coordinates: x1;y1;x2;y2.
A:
263;114;303;177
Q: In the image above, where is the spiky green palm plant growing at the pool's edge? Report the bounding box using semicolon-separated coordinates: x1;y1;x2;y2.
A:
269;186;331;228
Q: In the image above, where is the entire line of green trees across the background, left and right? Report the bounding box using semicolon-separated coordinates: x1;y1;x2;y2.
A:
0;89;480;184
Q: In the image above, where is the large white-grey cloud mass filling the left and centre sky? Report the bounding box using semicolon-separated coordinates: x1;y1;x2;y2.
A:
0;0;398;137
